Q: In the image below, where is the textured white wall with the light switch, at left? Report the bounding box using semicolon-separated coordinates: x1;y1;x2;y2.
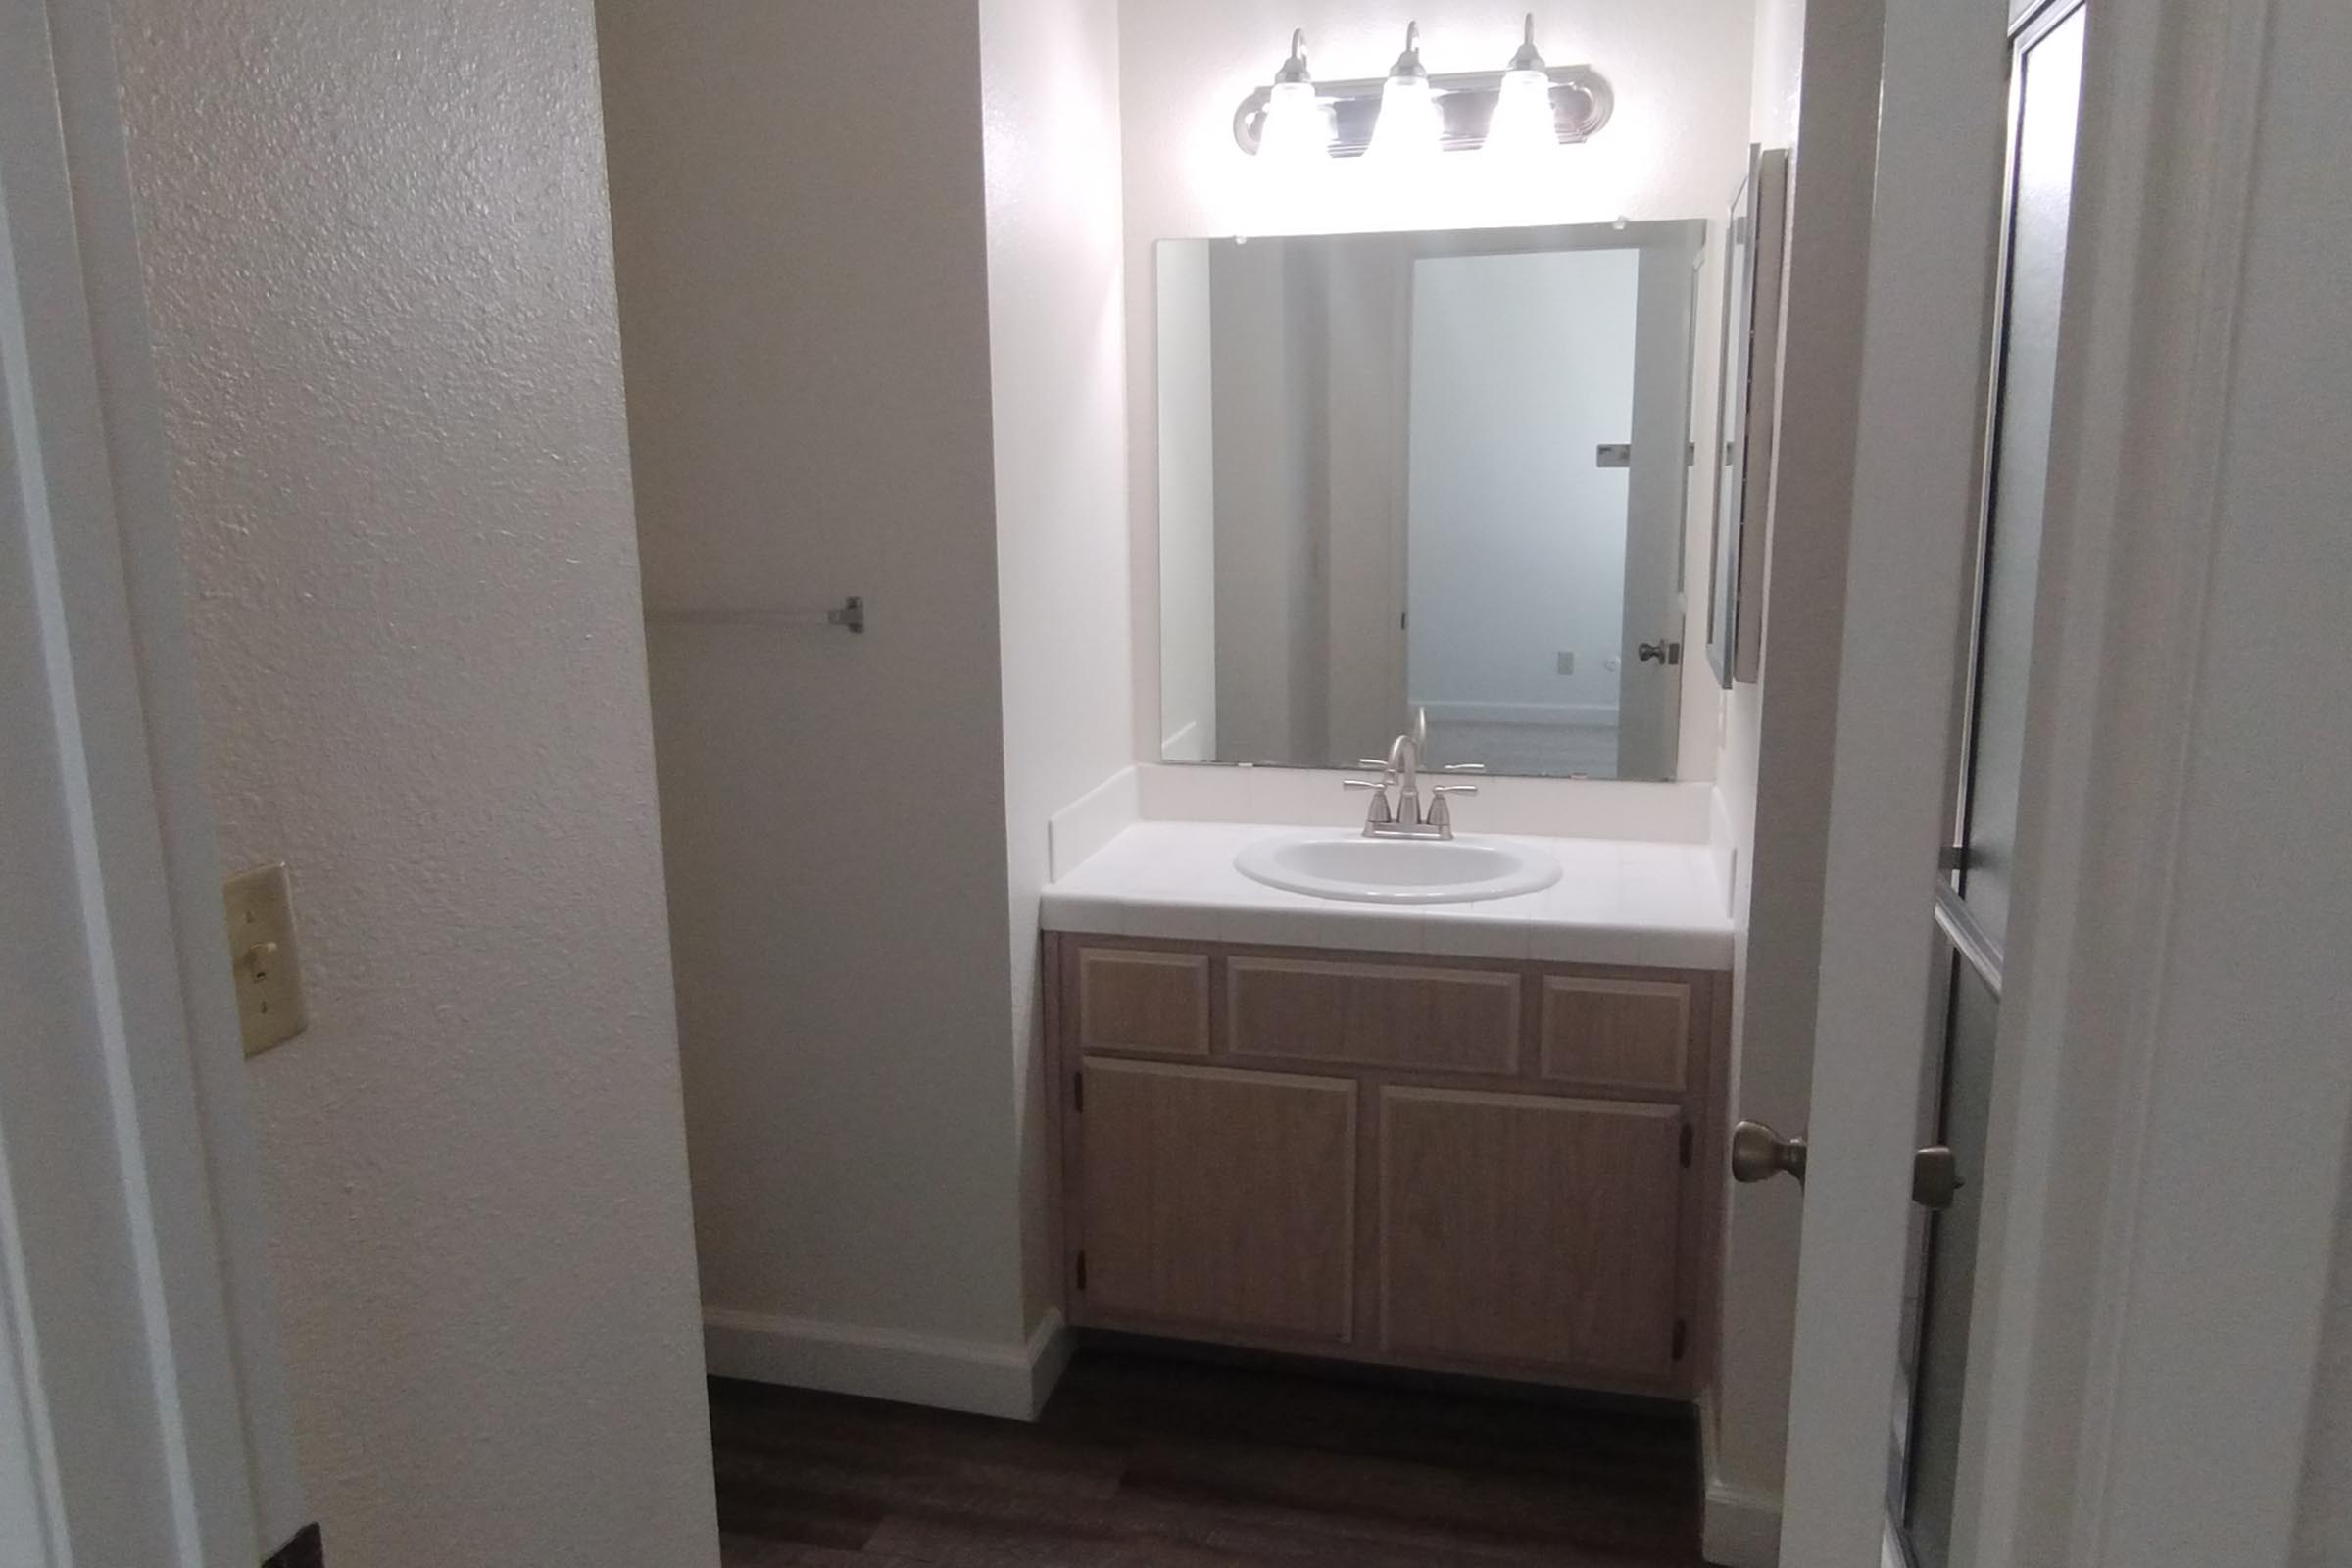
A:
113;0;717;1568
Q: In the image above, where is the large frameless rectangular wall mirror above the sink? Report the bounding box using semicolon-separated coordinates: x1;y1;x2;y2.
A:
1157;219;1712;778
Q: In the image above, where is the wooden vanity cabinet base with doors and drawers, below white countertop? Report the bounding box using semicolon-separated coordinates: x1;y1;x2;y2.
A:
1045;933;1729;1396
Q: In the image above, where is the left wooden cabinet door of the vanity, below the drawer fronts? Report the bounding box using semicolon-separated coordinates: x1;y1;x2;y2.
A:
1077;1057;1354;1343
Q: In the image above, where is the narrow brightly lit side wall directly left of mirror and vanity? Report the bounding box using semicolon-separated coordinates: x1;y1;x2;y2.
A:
978;0;1134;1324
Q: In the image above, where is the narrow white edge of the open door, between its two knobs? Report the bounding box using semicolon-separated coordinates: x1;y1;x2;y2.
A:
1781;0;2006;1568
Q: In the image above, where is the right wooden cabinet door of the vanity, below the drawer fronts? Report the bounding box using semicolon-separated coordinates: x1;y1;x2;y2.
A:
1381;1089;1682;1382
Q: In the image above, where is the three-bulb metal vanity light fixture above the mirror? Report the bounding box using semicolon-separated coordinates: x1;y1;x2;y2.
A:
1233;17;1613;167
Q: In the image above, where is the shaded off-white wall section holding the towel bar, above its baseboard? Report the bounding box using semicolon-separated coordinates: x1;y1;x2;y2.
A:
600;0;1030;1354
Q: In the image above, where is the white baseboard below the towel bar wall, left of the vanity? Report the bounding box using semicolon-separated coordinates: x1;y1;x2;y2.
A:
704;1307;1070;1420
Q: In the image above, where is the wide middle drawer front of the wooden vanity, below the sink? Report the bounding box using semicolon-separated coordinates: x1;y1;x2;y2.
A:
1225;959;1519;1074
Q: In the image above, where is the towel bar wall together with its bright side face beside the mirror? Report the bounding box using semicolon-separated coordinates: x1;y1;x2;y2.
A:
602;0;1134;1382
